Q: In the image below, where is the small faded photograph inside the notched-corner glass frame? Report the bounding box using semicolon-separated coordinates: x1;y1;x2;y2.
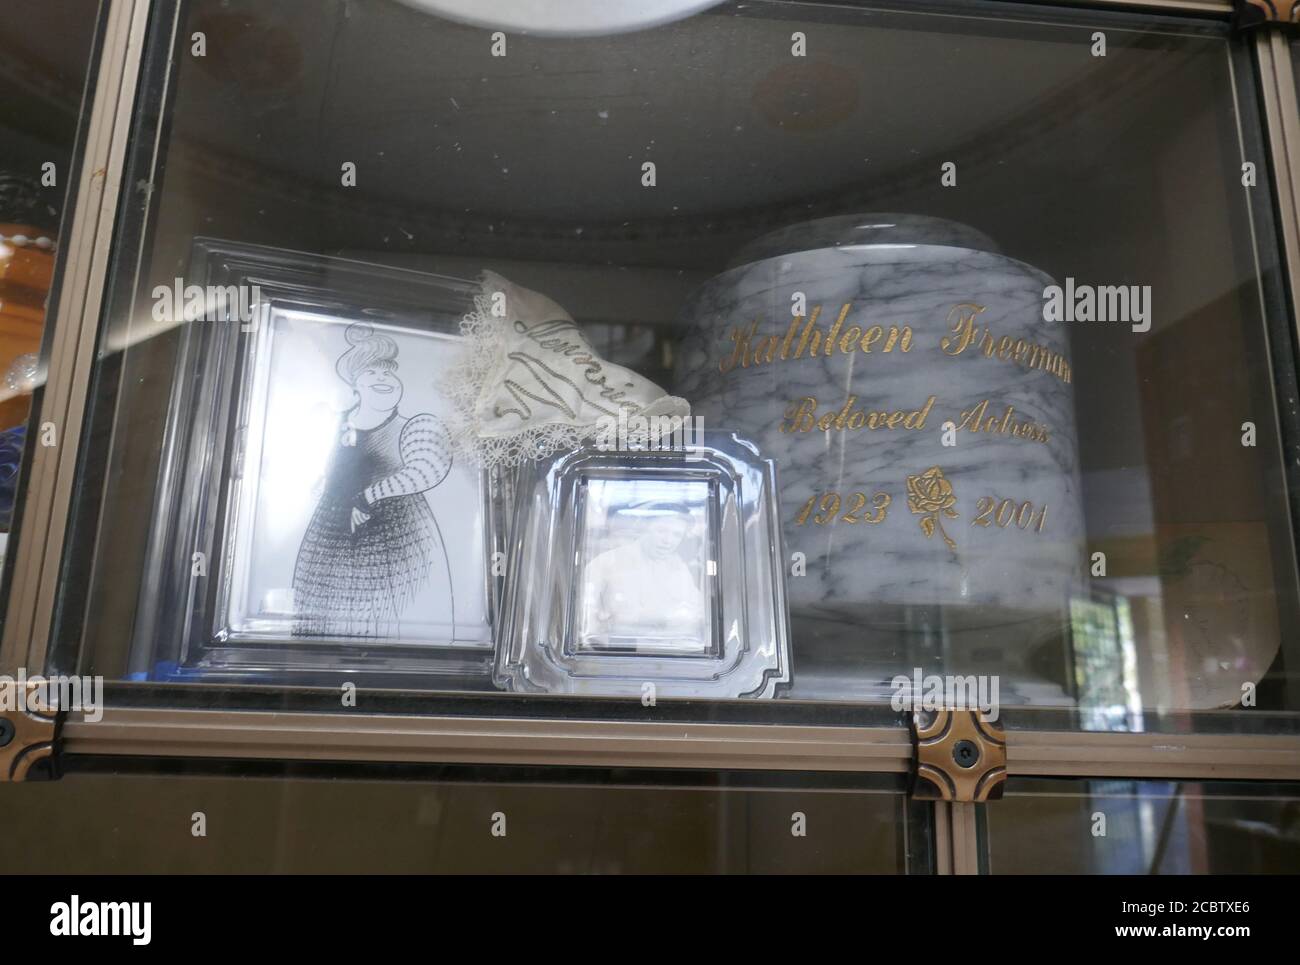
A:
575;477;718;655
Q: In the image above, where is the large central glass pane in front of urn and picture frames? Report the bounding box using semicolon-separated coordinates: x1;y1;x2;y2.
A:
52;0;1300;730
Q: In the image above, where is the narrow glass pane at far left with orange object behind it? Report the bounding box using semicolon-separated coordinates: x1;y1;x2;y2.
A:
0;0;99;614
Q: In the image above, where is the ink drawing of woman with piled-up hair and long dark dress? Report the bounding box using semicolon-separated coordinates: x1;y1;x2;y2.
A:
294;323;455;637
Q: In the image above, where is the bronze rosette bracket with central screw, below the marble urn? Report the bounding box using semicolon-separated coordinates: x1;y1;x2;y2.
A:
911;709;1006;801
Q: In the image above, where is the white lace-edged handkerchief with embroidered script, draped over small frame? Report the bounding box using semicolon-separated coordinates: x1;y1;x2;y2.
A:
447;272;690;467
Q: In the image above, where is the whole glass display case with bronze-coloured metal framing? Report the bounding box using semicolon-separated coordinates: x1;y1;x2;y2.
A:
0;0;1300;873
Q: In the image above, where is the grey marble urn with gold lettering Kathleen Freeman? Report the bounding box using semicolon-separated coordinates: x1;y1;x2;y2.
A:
673;215;1084;660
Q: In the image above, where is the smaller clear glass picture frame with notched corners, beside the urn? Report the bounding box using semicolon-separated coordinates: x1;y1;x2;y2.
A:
495;432;792;698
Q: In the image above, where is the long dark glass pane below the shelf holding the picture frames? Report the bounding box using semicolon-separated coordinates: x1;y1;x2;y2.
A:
0;761;933;874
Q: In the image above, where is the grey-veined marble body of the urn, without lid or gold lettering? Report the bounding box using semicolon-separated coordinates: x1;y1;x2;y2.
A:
675;241;1084;632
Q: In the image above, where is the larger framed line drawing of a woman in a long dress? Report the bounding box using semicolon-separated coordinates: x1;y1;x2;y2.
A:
133;241;499;688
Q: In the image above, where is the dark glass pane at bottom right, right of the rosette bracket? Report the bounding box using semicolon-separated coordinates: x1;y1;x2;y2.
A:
983;778;1300;874
